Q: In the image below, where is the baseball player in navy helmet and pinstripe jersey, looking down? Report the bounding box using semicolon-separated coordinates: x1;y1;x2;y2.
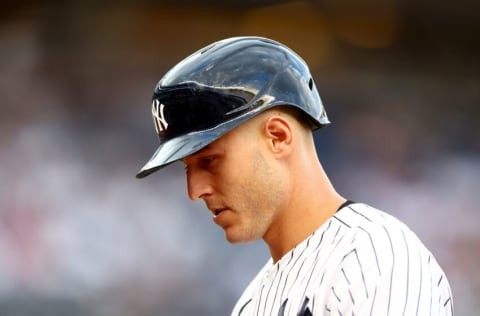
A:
137;37;453;316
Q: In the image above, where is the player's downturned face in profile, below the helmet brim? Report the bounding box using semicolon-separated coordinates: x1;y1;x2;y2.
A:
183;119;285;243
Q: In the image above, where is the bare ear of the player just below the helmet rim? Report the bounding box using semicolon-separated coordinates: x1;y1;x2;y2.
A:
264;115;293;156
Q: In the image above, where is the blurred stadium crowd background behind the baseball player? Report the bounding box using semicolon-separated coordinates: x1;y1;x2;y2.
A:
0;0;480;316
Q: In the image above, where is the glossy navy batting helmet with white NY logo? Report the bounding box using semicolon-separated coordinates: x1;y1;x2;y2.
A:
137;37;330;178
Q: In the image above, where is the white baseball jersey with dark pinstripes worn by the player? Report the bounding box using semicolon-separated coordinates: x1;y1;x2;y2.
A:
232;203;453;316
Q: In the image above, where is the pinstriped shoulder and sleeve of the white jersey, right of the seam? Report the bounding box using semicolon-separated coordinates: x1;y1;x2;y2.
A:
322;203;453;315
